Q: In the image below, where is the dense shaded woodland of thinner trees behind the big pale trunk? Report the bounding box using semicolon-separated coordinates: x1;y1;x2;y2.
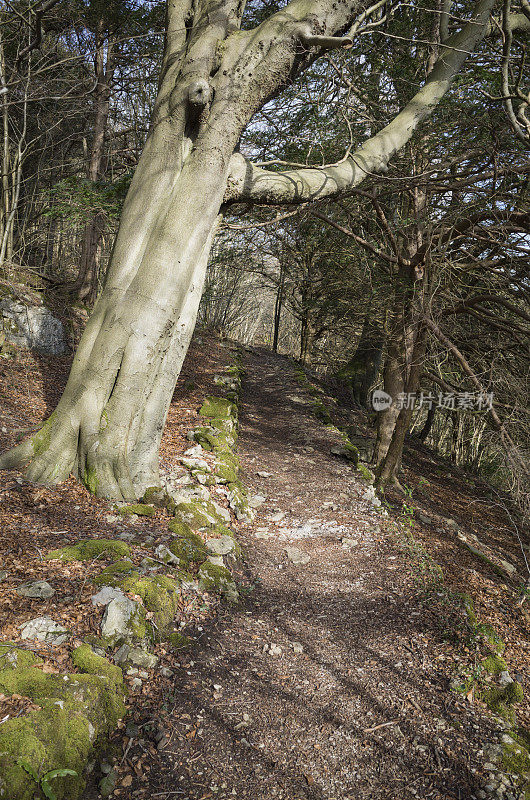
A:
0;0;530;507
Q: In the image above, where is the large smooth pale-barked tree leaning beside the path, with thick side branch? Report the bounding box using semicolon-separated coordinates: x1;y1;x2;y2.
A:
0;0;527;500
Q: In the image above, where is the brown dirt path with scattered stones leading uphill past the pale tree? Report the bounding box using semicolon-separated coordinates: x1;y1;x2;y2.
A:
131;354;496;800
